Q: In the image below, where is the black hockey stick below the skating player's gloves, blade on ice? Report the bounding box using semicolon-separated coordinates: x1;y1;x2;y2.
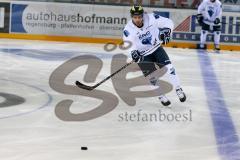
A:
75;61;134;91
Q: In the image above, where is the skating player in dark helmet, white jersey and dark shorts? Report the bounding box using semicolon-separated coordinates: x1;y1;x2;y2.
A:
123;5;186;106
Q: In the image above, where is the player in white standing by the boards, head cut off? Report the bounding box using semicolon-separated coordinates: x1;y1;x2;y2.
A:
197;0;222;50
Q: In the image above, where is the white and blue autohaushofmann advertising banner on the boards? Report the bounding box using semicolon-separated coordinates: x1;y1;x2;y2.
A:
11;4;127;35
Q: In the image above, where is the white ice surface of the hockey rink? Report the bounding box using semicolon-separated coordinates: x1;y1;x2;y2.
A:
0;39;240;160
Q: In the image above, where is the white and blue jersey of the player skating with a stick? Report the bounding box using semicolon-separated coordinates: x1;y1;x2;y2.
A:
123;13;173;56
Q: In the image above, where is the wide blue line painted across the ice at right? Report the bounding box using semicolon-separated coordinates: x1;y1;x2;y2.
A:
198;50;240;160
